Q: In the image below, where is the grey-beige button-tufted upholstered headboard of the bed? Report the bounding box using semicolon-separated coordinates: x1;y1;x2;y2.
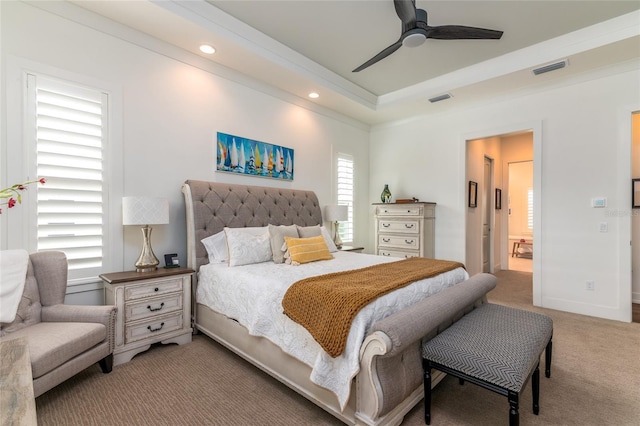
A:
182;180;322;271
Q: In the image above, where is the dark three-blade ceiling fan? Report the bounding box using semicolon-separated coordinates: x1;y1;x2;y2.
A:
353;0;502;72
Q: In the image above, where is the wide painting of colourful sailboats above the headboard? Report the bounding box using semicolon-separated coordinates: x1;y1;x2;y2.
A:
216;132;295;180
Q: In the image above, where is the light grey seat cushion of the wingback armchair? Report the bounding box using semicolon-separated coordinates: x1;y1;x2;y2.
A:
3;322;107;379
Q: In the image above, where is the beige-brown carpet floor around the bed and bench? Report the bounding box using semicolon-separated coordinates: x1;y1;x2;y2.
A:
36;271;640;426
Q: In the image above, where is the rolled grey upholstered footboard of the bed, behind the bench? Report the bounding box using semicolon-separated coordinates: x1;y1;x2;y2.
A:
356;274;497;425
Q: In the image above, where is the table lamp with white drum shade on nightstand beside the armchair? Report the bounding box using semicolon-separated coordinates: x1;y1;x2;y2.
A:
122;197;169;272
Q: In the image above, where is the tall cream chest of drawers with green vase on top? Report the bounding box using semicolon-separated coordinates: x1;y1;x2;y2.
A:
374;202;436;258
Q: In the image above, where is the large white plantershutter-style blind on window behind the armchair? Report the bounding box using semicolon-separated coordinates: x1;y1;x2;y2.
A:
28;75;108;283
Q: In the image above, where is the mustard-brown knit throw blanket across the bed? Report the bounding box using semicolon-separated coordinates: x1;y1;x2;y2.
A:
282;257;464;358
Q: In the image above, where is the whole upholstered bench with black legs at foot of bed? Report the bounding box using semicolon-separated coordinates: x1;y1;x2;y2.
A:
422;303;553;426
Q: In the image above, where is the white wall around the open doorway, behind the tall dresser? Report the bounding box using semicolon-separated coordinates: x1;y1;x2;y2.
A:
370;65;640;321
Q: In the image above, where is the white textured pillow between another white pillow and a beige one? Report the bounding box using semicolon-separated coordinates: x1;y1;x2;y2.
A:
224;226;273;266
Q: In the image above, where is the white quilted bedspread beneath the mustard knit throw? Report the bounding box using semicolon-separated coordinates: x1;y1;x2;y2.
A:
196;252;469;409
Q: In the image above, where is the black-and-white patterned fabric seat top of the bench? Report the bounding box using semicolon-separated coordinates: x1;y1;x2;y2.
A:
422;303;553;392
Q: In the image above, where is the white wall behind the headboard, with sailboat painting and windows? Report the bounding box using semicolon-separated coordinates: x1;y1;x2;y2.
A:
0;2;369;298
